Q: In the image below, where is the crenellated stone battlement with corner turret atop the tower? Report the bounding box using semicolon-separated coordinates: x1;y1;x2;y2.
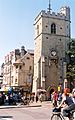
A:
35;6;70;21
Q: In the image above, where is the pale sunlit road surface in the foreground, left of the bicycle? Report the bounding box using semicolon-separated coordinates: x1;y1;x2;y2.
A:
0;105;51;120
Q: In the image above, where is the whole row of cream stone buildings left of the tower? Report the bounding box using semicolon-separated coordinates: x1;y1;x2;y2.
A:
3;46;34;90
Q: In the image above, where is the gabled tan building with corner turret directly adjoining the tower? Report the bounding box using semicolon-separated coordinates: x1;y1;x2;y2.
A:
11;52;34;92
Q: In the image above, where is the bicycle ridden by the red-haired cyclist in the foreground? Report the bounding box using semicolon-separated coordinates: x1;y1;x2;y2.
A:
51;110;75;120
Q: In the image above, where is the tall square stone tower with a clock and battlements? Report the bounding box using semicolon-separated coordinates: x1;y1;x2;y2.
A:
33;6;70;93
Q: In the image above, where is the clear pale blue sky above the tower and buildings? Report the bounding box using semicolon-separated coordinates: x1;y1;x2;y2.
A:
0;0;75;69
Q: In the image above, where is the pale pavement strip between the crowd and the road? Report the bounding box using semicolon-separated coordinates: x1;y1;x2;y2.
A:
0;101;52;109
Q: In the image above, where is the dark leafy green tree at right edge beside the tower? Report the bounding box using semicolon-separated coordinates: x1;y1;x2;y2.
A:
66;40;75;89
